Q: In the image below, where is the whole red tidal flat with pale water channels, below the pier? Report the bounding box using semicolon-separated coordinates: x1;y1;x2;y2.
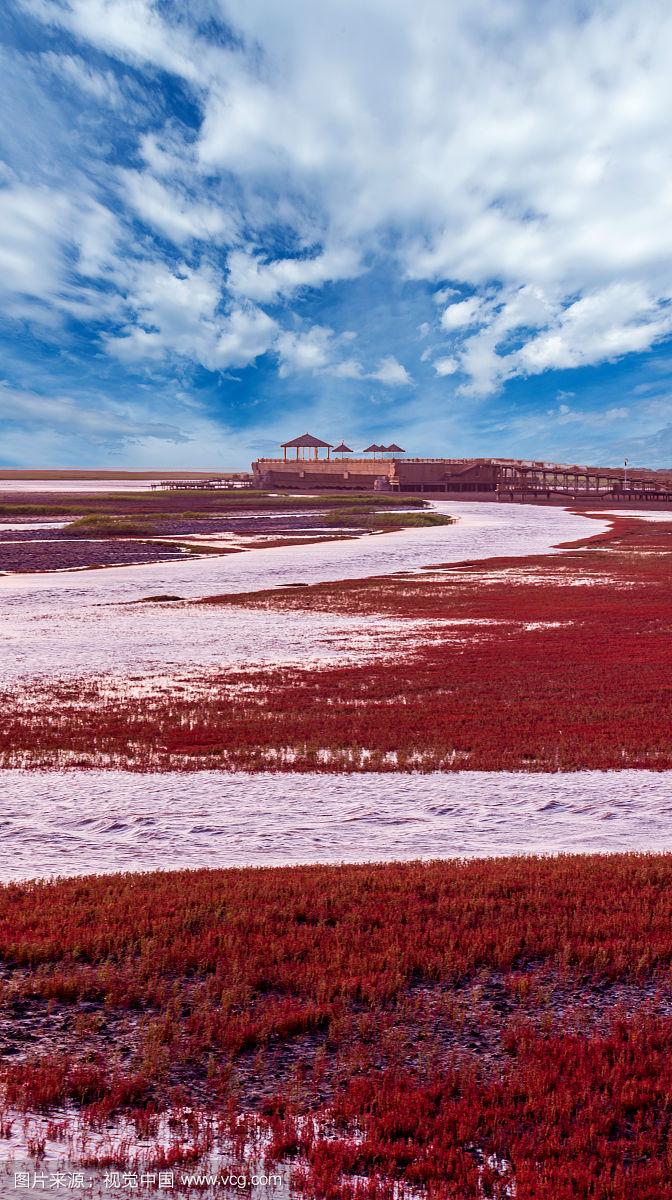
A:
0;491;672;1200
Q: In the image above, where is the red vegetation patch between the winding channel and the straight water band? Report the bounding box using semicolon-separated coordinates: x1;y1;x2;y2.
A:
7;518;672;772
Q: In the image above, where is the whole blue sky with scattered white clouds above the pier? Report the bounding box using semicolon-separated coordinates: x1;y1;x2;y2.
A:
0;0;672;468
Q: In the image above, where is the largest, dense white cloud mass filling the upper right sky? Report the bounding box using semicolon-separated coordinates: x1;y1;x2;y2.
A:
199;0;672;392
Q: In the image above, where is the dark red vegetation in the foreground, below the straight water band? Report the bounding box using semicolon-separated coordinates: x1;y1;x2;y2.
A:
0;854;672;1200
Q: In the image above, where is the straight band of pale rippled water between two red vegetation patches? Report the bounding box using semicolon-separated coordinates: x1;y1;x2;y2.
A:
0;770;672;881
